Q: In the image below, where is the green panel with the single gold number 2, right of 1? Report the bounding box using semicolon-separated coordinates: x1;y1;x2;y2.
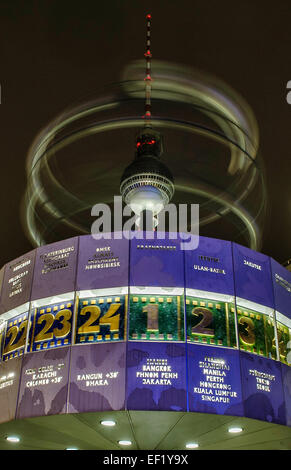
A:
186;296;237;348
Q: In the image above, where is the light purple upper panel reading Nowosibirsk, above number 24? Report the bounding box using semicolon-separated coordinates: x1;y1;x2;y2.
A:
76;235;129;290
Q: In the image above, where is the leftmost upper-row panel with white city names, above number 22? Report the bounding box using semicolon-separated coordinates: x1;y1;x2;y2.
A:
1;250;36;312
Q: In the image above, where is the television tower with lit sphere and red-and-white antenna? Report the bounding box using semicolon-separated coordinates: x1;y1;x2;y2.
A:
120;15;174;225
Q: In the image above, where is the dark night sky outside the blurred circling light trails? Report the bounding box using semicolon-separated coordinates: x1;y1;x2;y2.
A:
0;0;291;265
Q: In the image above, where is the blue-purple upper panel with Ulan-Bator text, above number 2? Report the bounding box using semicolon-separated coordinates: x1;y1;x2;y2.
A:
185;237;234;295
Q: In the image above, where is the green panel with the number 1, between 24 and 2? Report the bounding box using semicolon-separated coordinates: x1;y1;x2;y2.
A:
129;294;184;341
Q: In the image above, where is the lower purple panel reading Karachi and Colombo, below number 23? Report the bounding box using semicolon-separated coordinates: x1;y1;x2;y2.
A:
16;347;70;418
